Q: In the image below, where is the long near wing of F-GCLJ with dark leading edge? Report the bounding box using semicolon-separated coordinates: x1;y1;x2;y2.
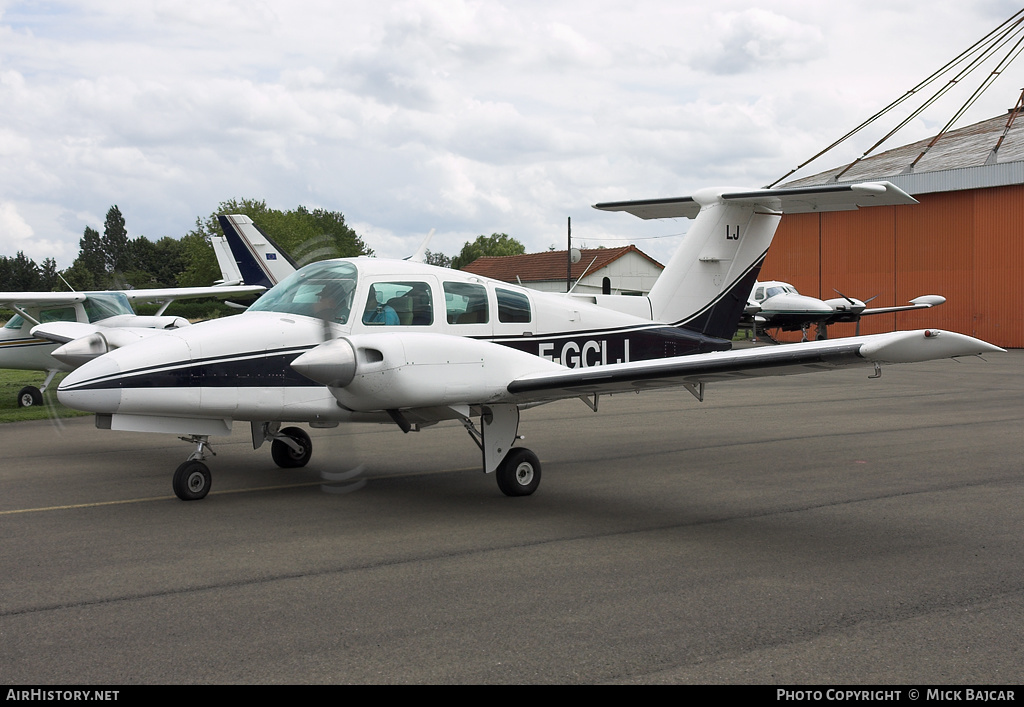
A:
508;329;1004;403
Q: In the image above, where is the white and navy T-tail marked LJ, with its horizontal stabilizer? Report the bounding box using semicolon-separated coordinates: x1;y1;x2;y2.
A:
594;181;916;339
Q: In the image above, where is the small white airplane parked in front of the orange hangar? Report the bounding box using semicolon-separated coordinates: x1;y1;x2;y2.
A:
743;280;946;341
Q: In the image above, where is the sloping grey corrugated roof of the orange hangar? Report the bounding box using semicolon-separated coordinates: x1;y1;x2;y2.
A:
785;114;1024;195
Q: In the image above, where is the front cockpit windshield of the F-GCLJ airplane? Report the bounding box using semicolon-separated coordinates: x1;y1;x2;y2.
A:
249;260;357;324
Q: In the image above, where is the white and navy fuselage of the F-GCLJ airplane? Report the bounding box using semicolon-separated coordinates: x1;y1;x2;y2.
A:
59;253;730;433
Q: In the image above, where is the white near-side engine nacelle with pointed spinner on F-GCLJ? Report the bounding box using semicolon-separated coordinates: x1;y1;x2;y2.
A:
292;332;560;412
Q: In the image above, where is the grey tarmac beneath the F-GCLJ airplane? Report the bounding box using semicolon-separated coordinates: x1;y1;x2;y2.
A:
0;350;1024;685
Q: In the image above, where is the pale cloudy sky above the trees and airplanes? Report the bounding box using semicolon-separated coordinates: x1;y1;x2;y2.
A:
0;0;1024;267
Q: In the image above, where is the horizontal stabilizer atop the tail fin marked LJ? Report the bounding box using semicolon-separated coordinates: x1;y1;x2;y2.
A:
594;181;918;218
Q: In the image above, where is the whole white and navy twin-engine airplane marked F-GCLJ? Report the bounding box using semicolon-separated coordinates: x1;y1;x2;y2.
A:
54;182;1002;500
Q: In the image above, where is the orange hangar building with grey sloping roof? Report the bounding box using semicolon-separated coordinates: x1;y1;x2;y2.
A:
760;112;1024;348
